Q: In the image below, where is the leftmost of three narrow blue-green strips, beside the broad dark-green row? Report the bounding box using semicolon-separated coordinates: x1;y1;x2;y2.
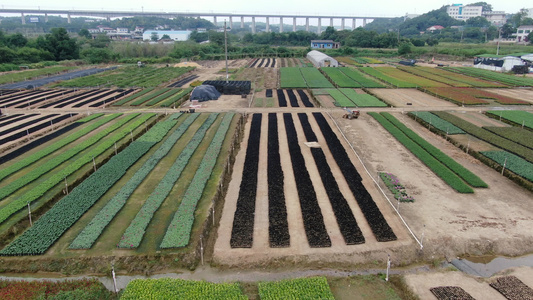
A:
69;114;190;249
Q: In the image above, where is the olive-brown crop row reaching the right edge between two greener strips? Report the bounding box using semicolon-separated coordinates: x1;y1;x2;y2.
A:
433;112;533;162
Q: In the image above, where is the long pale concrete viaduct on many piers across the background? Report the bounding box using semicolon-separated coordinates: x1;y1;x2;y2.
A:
0;8;397;33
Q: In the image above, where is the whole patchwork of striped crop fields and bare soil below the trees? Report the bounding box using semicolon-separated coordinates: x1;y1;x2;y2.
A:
0;58;533;299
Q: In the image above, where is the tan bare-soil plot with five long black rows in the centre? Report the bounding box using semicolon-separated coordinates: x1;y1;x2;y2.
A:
215;113;401;263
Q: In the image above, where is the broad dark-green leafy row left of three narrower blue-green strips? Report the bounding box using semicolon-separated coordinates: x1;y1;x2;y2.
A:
0;114;159;255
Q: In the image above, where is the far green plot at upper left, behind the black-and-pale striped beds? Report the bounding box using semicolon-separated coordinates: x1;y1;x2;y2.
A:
54;66;194;88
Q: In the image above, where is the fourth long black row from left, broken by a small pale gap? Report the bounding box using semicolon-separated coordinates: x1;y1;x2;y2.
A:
298;113;365;245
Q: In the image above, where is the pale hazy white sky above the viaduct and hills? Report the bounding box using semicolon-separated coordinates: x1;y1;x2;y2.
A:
0;0;533;17
